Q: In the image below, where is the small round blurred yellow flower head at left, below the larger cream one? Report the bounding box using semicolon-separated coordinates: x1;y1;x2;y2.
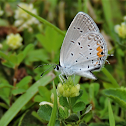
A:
7;33;23;49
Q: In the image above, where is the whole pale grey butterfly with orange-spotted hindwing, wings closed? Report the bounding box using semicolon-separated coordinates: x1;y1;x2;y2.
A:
55;12;108;79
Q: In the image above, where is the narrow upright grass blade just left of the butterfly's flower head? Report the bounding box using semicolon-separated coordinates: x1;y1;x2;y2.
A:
48;83;57;126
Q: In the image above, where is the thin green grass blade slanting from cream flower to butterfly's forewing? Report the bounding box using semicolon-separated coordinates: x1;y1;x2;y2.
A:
18;6;65;36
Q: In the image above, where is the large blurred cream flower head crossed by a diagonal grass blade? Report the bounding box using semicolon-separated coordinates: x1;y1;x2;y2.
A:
14;3;39;31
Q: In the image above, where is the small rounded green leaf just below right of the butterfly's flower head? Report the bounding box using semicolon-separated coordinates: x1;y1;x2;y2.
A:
72;101;85;112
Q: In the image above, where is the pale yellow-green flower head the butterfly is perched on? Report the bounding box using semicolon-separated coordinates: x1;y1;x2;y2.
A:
57;80;80;97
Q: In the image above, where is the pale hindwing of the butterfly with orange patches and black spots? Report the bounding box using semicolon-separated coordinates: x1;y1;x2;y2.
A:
64;32;108;79
